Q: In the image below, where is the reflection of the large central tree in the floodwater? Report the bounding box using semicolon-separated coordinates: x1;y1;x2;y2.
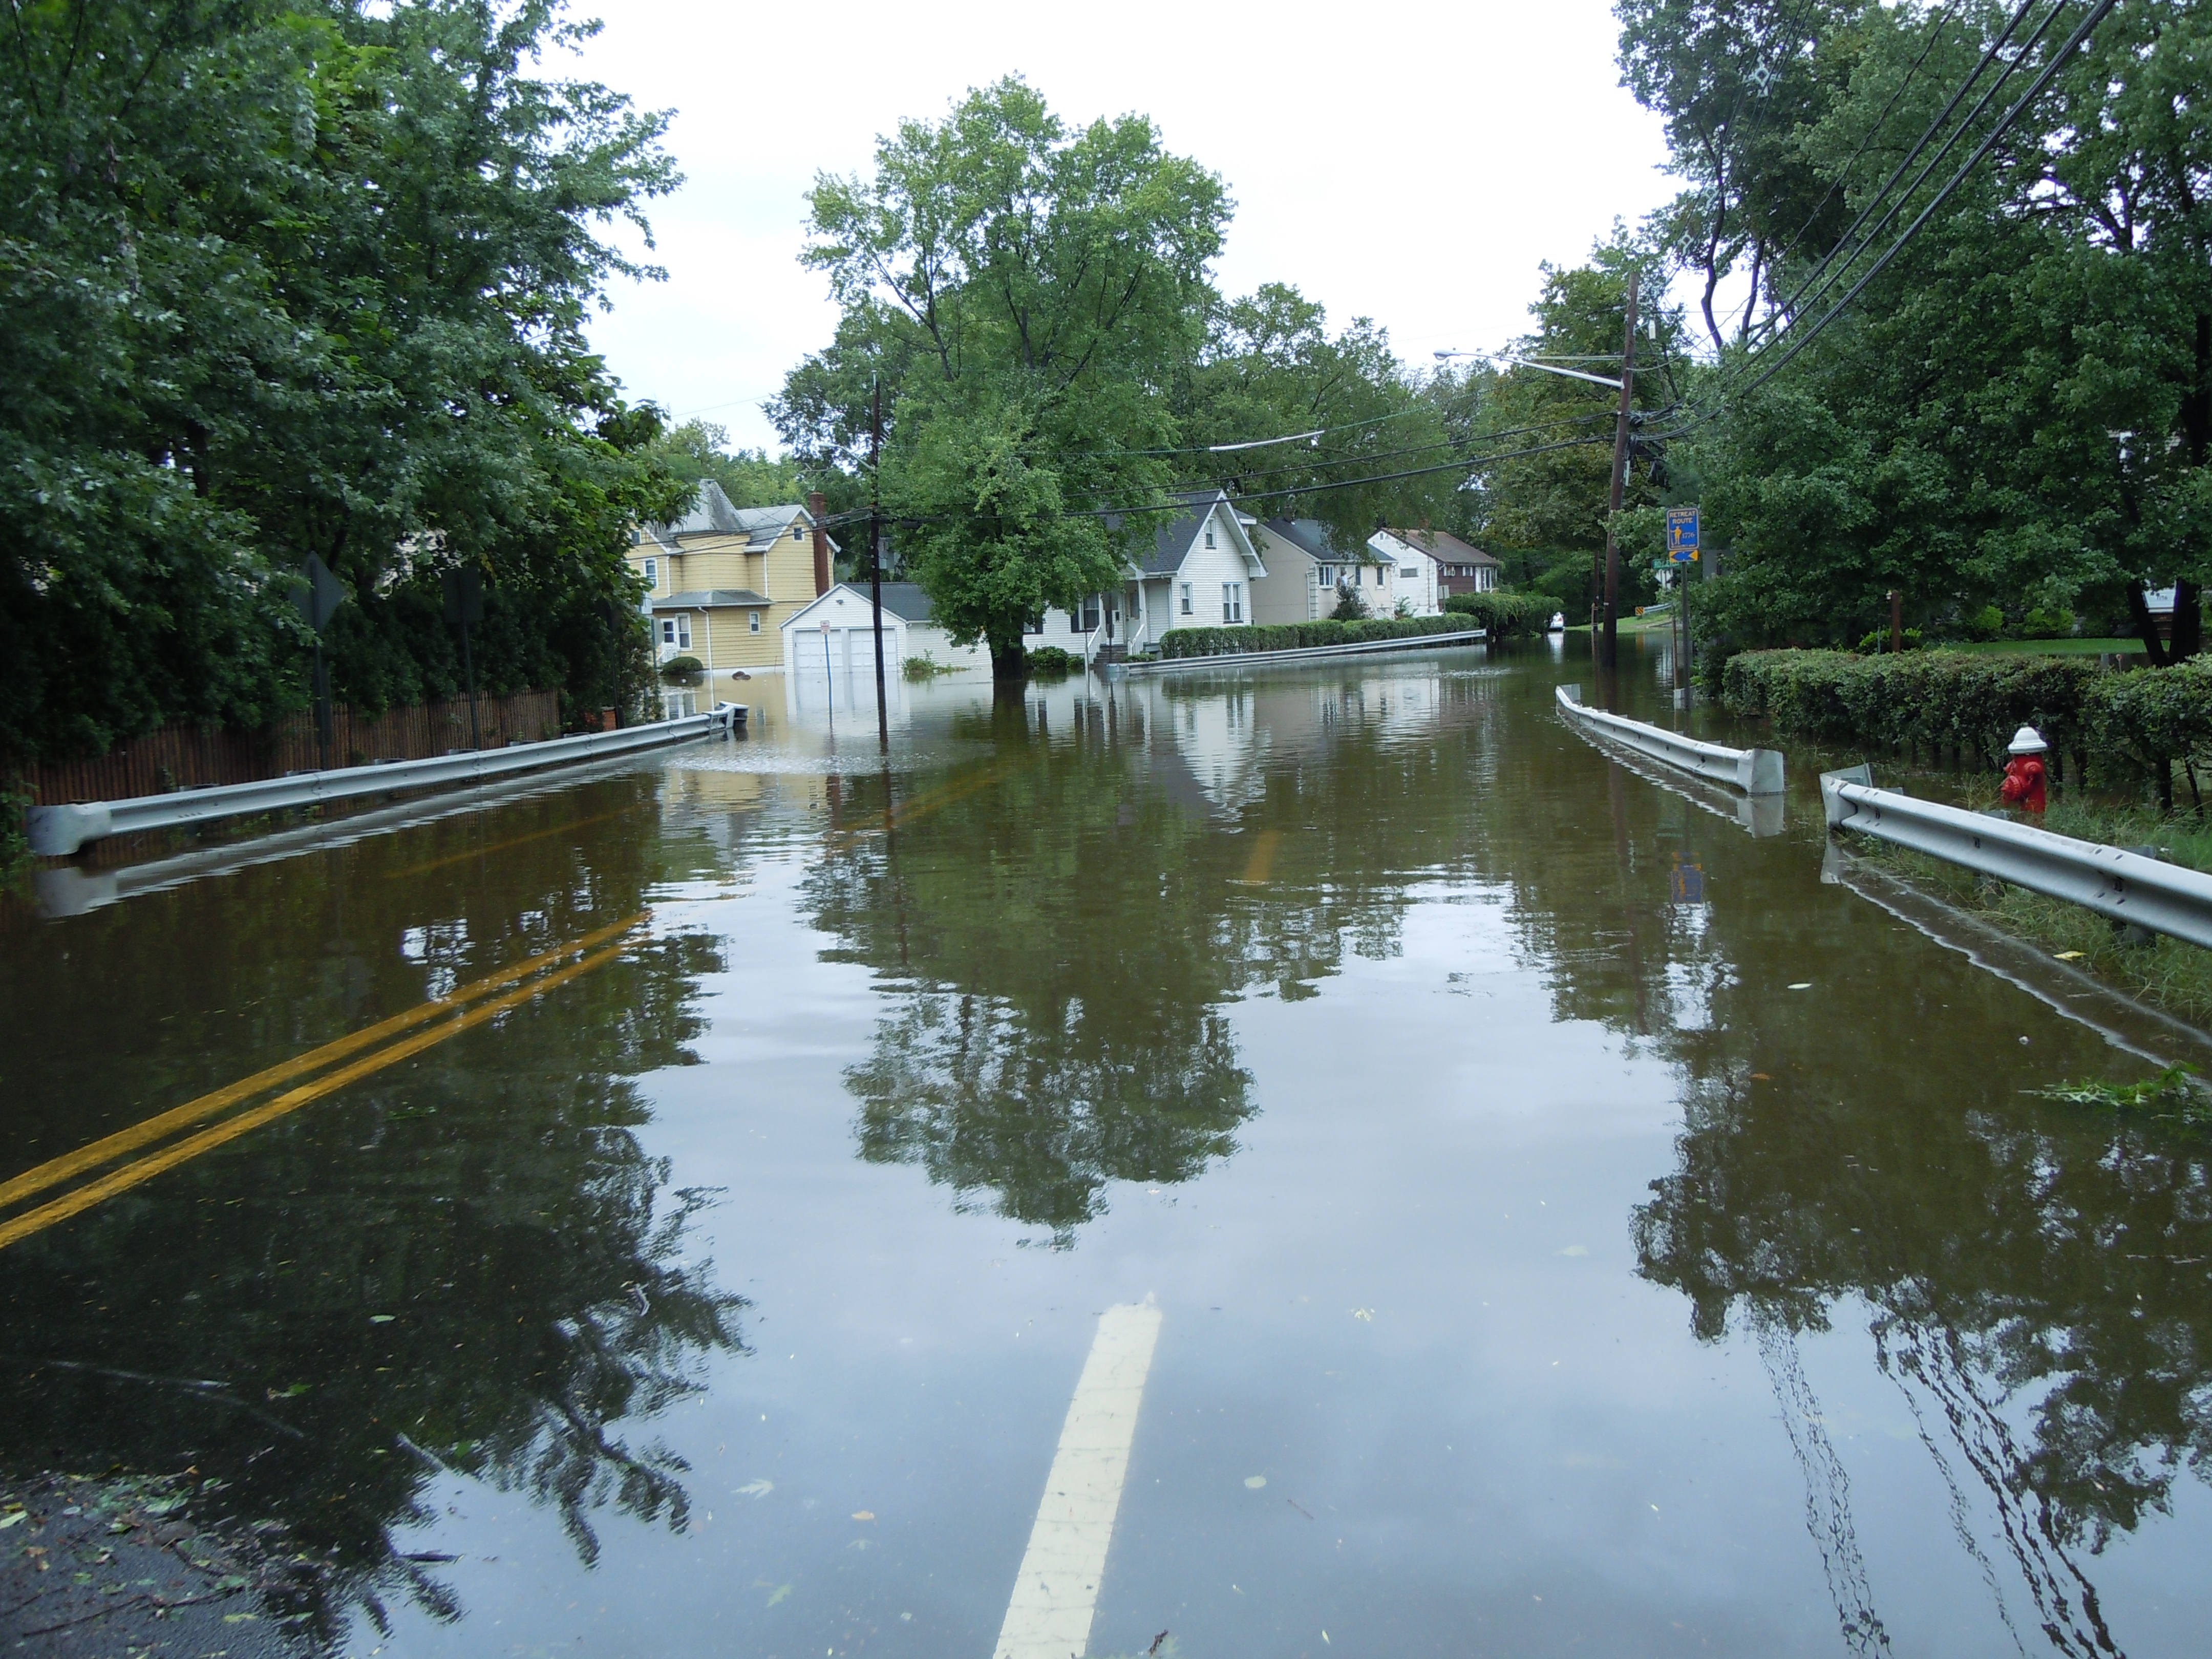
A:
807;686;1471;1245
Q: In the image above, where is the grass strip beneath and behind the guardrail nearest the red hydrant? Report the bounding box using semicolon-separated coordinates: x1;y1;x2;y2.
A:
1847;801;2212;1029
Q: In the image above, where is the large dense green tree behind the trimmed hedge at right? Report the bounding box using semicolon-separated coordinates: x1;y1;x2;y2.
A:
1622;0;2212;659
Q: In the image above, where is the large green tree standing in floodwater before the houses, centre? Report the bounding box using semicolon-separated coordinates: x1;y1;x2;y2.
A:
774;80;1230;677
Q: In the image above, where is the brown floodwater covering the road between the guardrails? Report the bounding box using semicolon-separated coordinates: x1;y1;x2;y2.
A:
0;646;2212;1659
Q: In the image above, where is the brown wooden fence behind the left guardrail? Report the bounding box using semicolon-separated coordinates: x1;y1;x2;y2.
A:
22;692;560;805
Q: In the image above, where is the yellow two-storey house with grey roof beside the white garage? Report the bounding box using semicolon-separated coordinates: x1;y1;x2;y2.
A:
630;478;836;717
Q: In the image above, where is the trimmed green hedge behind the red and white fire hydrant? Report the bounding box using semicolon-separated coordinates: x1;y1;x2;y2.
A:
1721;650;2212;772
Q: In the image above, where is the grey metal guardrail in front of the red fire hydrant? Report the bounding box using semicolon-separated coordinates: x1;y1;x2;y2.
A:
1820;765;2212;947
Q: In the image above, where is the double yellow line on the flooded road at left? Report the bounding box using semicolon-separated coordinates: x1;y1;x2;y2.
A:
0;911;650;1250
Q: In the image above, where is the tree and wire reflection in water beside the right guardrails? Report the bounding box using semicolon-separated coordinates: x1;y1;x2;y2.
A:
1451;708;2212;1654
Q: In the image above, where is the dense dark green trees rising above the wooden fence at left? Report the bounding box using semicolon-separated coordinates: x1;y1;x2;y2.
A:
0;0;675;759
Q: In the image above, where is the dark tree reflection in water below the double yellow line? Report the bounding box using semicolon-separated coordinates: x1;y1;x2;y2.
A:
0;900;746;1634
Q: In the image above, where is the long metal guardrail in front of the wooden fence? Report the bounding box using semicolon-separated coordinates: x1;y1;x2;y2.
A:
25;704;746;858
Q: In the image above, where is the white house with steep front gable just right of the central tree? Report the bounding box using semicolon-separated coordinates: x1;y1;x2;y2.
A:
1024;489;1267;657
